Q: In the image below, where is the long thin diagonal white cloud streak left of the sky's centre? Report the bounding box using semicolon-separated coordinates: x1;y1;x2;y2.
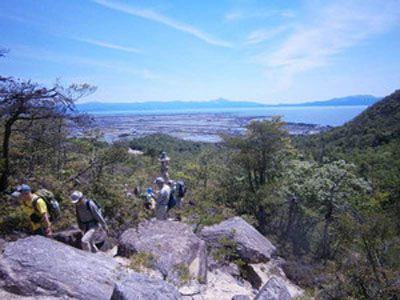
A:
92;0;232;47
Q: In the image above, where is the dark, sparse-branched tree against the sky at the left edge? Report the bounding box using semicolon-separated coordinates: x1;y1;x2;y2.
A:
0;78;95;192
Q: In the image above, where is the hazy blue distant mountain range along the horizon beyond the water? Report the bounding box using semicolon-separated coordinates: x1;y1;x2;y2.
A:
77;95;381;113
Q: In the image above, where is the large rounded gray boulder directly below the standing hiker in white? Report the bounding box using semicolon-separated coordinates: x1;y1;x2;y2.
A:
118;220;207;285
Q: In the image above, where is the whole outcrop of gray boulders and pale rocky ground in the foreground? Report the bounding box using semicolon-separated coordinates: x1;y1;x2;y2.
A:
0;217;303;300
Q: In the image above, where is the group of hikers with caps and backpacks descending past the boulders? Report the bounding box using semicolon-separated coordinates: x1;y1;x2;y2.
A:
11;152;186;252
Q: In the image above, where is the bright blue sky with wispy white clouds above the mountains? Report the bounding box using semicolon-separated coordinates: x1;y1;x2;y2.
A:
0;0;400;103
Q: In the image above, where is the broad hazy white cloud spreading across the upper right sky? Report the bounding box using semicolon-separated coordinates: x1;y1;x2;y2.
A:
256;0;400;88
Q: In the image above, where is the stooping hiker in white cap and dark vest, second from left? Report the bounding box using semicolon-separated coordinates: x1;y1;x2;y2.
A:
70;191;108;253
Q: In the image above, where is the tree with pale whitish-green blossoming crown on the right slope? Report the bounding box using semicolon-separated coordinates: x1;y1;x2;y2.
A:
287;160;371;259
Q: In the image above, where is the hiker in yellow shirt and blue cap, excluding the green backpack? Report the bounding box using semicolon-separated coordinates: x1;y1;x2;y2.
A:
11;184;53;236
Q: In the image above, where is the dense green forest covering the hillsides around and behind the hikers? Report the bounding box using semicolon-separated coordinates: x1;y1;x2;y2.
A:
0;54;400;299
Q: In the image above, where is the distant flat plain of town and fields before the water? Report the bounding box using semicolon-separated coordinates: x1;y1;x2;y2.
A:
88;113;331;143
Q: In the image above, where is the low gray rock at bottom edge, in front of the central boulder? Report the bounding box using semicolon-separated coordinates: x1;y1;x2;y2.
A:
110;274;181;300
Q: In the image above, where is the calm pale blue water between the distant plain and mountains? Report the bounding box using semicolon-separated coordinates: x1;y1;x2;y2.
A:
92;105;368;126
